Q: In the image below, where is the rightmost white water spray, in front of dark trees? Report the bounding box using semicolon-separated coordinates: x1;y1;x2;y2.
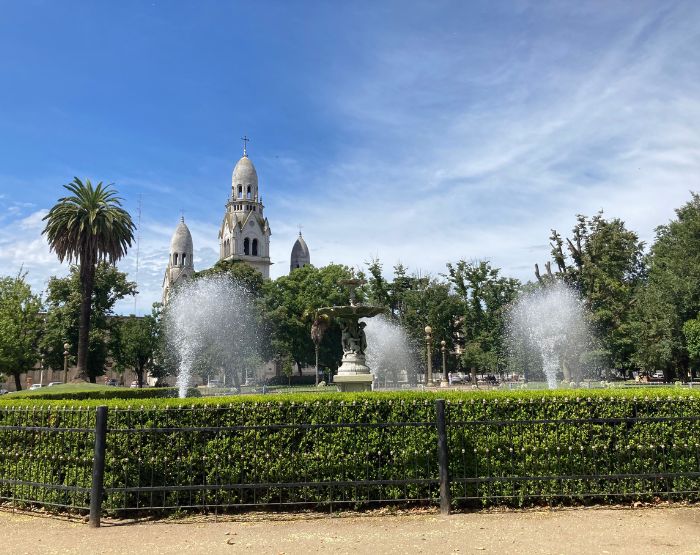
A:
508;282;590;389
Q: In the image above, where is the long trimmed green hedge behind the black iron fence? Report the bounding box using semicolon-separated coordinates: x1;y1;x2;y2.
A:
0;388;700;513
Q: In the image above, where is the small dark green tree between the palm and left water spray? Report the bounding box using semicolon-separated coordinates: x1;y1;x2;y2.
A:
111;315;158;387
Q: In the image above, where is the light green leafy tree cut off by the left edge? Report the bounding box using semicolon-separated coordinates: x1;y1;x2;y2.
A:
0;274;42;391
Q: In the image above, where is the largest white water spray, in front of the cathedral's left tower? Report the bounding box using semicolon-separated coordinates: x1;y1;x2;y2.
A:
165;276;261;397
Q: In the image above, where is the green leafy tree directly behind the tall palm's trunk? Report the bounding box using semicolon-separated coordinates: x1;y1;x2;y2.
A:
41;262;136;383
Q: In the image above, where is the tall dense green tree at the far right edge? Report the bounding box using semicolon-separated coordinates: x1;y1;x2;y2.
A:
635;193;700;380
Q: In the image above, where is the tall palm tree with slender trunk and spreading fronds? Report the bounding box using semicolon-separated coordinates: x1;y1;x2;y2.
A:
42;177;135;378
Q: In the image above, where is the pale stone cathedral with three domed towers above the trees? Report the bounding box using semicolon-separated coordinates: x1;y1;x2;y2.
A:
163;139;311;303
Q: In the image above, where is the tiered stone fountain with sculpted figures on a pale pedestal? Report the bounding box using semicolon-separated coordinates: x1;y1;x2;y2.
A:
318;271;384;391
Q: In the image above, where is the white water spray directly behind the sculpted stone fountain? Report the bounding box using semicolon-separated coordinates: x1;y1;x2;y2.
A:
363;315;418;387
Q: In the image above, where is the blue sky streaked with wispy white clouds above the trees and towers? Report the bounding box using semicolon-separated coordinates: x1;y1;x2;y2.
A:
0;0;700;312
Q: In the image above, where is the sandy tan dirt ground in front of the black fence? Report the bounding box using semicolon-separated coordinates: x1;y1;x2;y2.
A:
0;506;700;555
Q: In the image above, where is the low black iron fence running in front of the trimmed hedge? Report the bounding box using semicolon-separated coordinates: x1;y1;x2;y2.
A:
0;400;700;526
